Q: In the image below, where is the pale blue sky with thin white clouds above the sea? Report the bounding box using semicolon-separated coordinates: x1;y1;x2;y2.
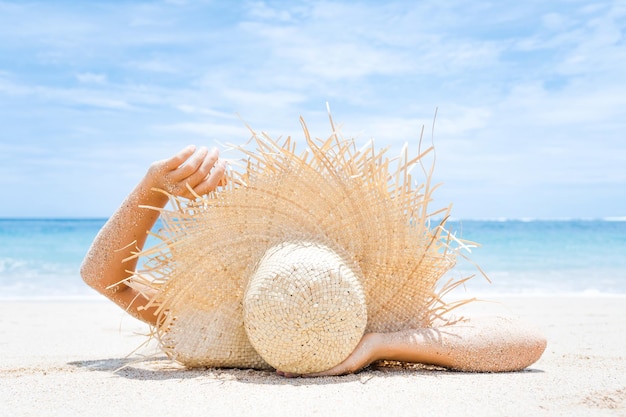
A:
0;0;626;218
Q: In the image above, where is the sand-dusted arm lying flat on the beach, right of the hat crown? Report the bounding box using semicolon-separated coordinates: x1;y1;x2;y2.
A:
286;317;546;376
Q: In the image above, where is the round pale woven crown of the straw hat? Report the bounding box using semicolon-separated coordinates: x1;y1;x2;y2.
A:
243;242;367;374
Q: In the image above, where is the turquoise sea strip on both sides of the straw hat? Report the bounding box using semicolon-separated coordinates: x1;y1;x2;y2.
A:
0;219;626;300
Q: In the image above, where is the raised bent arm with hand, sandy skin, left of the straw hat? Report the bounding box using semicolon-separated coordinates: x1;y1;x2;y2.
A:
81;146;225;324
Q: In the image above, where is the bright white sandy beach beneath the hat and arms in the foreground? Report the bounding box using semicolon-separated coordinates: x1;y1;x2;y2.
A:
0;296;626;417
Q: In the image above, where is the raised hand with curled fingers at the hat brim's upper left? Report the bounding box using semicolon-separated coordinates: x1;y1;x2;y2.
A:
145;145;226;198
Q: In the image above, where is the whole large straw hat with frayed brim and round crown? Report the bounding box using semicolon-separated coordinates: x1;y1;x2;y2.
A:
134;112;466;373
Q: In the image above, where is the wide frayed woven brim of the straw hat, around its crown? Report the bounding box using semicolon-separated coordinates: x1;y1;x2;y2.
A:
134;114;467;370
